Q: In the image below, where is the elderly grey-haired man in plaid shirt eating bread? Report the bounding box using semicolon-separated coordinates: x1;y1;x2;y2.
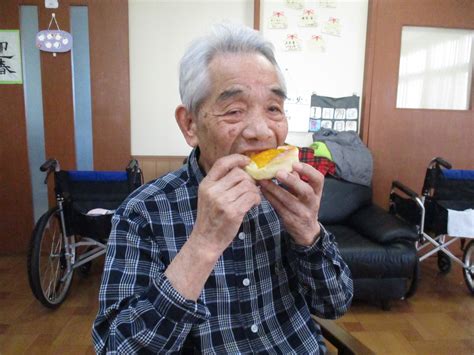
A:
93;25;353;354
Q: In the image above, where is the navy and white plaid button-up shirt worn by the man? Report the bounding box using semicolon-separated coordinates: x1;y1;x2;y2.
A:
93;150;353;354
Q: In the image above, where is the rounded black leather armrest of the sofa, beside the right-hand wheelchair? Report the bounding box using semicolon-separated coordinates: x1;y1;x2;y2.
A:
347;205;418;244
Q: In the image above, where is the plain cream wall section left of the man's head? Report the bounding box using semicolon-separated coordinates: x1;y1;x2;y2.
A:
129;0;253;156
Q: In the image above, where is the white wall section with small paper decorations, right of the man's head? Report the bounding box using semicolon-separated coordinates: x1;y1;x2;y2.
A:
260;0;368;146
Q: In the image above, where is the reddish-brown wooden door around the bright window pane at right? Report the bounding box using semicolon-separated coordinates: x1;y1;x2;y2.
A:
362;0;474;207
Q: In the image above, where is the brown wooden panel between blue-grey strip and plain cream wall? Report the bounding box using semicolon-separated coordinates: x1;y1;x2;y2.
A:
89;0;131;170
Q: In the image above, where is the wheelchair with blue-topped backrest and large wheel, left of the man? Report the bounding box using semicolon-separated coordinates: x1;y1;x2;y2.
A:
27;159;143;309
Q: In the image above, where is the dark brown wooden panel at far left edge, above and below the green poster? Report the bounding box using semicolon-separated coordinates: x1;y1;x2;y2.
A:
0;0;33;254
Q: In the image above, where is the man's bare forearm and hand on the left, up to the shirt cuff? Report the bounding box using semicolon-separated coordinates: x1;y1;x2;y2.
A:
165;154;260;300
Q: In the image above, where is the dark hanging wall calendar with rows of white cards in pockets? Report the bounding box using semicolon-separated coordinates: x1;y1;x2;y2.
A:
309;95;360;132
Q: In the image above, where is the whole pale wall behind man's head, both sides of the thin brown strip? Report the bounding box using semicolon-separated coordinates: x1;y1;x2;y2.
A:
129;0;368;156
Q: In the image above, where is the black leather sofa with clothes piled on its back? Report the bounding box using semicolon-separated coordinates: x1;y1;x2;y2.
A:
319;177;418;309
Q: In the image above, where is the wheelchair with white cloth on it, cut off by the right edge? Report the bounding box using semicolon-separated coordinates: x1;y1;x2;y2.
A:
389;157;474;294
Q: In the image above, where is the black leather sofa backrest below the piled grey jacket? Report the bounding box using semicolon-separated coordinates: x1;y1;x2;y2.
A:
319;177;372;224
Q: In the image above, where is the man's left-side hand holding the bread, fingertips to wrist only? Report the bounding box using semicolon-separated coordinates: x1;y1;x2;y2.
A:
191;154;261;258
